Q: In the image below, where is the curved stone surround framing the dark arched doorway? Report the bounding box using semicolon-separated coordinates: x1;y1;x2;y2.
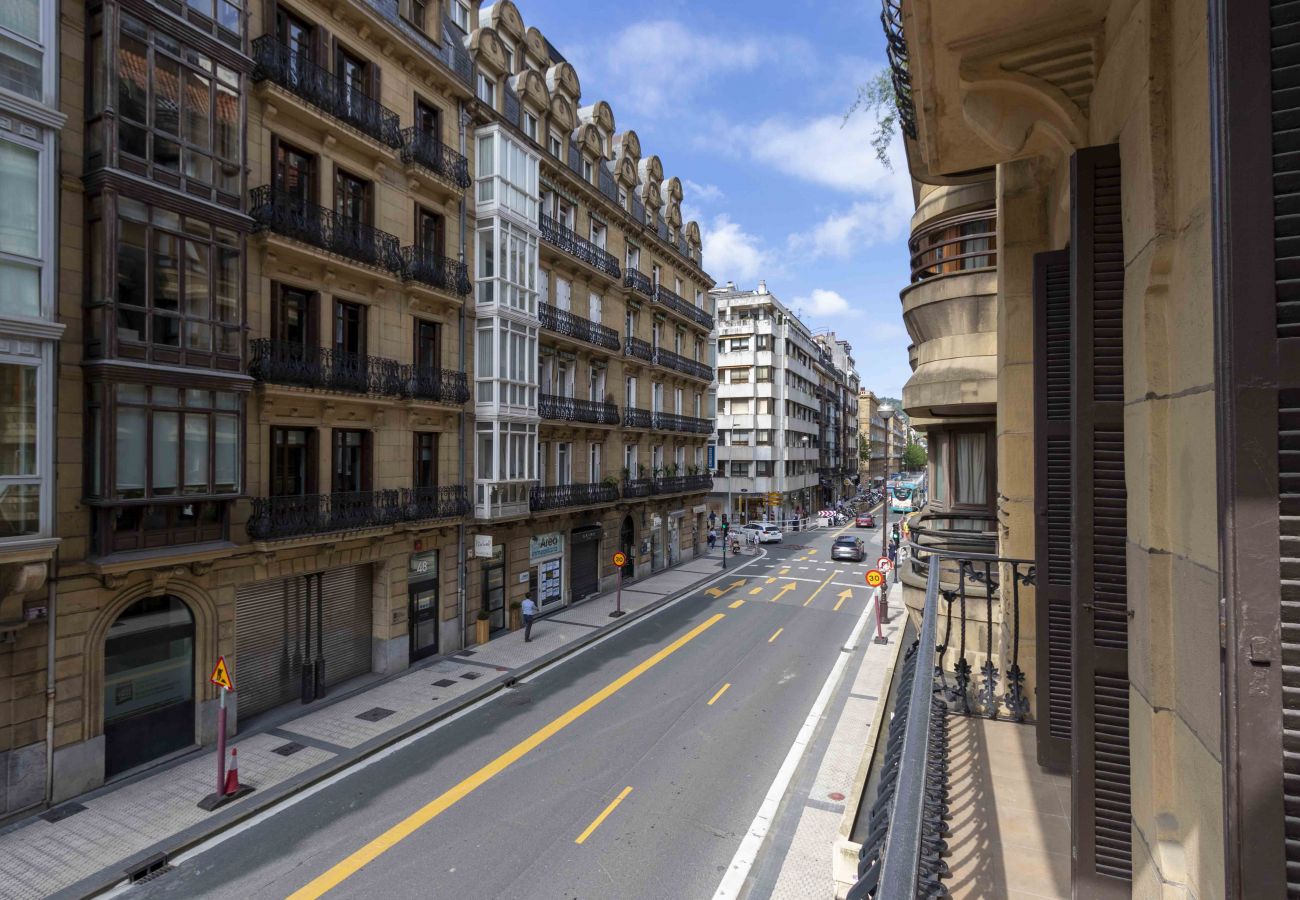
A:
82;579;221;739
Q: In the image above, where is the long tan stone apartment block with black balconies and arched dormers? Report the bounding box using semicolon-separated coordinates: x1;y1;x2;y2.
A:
43;0;712;801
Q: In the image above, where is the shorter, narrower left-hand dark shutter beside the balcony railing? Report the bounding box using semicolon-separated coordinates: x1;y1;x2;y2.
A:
1029;250;1074;771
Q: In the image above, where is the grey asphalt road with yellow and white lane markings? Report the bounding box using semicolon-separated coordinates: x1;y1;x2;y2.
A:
129;517;879;900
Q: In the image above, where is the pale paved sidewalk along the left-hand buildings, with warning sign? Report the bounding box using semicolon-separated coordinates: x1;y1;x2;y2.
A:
0;553;762;900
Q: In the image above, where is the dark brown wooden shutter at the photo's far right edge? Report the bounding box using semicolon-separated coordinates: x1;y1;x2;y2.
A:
1208;0;1300;897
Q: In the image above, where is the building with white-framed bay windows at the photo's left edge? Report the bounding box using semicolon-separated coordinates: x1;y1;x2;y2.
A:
0;0;69;817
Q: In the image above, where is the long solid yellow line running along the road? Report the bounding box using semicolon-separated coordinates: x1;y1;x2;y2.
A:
289;608;728;900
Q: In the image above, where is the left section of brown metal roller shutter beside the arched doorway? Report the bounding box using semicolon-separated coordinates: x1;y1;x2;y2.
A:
234;577;307;717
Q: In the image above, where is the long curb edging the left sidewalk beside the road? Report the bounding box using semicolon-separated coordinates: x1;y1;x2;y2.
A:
61;550;767;900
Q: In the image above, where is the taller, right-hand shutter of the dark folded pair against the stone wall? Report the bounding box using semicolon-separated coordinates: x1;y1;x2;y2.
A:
1070;144;1132;897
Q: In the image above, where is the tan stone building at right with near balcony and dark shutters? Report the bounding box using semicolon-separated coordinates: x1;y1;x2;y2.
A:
855;0;1300;897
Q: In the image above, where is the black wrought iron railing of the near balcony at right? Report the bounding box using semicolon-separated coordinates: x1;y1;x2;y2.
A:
848;528;1035;900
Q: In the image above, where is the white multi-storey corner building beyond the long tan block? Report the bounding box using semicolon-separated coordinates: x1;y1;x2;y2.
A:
710;281;822;522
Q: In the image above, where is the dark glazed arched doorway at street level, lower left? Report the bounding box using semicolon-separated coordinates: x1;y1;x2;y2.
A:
104;594;194;778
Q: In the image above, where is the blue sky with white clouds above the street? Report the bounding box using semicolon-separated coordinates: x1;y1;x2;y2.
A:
516;0;913;397
